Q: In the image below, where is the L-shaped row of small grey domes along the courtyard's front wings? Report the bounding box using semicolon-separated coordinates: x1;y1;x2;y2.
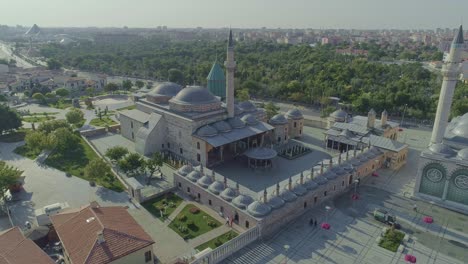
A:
178;148;381;217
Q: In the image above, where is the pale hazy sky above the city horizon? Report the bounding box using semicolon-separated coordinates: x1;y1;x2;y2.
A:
0;0;468;29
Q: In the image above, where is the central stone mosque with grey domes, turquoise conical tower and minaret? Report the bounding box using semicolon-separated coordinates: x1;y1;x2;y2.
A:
119;31;303;167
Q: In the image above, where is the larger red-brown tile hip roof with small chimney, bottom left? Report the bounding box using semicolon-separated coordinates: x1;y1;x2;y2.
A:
51;205;154;264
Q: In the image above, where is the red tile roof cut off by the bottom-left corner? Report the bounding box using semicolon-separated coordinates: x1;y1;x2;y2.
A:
0;227;54;264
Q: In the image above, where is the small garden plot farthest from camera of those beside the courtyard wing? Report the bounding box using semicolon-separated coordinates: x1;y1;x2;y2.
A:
141;193;183;220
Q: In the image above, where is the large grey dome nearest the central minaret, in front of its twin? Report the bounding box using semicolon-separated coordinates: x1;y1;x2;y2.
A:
172;86;219;105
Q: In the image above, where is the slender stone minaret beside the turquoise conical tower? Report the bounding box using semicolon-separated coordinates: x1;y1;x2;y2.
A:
224;30;236;117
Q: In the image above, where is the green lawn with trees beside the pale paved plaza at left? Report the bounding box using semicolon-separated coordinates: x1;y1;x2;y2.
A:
45;138;125;192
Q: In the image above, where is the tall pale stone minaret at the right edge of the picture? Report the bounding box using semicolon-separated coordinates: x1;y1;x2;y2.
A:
431;26;463;145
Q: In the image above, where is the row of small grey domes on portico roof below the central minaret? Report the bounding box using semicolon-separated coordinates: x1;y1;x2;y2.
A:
197;114;259;137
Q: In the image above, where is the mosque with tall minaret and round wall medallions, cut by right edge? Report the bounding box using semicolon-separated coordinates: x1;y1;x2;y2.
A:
415;26;468;213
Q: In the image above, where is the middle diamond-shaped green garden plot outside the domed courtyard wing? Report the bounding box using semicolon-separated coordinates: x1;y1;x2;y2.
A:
169;204;221;239
